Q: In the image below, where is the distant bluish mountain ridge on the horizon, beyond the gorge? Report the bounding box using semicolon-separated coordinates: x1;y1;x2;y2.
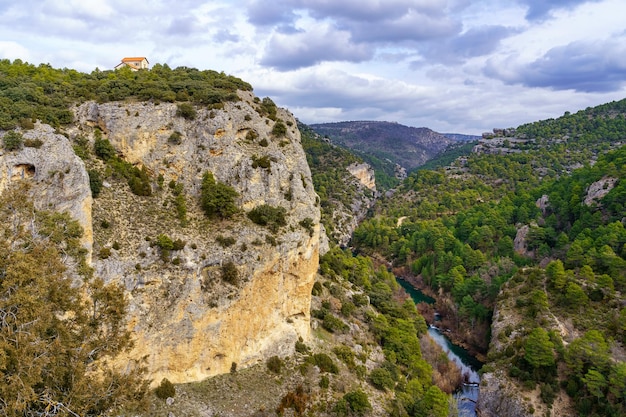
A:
309;121;455;170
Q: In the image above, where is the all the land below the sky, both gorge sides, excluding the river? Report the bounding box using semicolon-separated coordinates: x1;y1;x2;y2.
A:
0;60;626;417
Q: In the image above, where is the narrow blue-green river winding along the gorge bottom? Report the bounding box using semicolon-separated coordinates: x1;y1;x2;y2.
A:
397;278;482;417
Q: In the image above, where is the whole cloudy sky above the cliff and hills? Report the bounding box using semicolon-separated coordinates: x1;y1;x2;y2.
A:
0;0;626;134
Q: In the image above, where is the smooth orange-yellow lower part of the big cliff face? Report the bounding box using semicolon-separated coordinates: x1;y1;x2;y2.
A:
130;239;319;383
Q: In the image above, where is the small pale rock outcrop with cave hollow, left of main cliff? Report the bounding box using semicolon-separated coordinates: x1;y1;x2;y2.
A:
0;123;93;255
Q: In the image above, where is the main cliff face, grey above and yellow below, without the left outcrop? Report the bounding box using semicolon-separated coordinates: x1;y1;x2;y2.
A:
76;96;320;384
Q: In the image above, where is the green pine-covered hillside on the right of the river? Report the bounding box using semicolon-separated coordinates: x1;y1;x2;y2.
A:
353;96;626;416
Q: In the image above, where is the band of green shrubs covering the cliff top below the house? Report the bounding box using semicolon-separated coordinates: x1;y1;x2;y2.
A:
0;59;252;130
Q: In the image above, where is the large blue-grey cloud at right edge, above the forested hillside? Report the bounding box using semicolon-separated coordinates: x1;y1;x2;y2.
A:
485;40;626;92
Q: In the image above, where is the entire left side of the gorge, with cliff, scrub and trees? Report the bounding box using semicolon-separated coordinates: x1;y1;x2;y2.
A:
0;57;460;417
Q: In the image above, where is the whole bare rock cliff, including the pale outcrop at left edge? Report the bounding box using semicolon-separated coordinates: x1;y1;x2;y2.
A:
0;91;320;383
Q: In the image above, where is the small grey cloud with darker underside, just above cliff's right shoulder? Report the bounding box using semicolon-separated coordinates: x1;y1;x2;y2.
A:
261;26;373;71
